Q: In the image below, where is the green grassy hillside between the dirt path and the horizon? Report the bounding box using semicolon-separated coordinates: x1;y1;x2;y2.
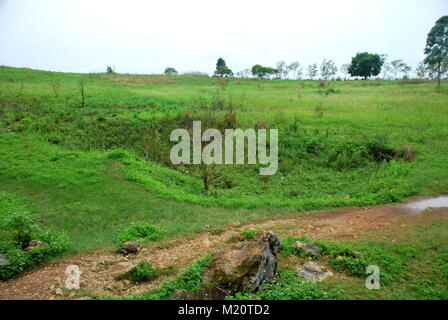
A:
0;67;448;249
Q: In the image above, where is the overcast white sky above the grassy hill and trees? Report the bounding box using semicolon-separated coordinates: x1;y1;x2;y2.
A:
0;0;448;73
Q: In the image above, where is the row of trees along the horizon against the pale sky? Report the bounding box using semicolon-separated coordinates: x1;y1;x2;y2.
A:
152;16;448;87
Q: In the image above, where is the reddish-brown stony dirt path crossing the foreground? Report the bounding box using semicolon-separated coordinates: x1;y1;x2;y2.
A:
0;201;448;300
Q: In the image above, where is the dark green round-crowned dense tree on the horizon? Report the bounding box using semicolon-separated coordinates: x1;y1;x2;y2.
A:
348;52;384;80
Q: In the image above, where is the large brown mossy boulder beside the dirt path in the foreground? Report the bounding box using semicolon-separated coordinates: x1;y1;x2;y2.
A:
202;232;280;292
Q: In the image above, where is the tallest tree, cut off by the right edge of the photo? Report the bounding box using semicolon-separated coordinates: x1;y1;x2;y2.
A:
424;16;448;88
